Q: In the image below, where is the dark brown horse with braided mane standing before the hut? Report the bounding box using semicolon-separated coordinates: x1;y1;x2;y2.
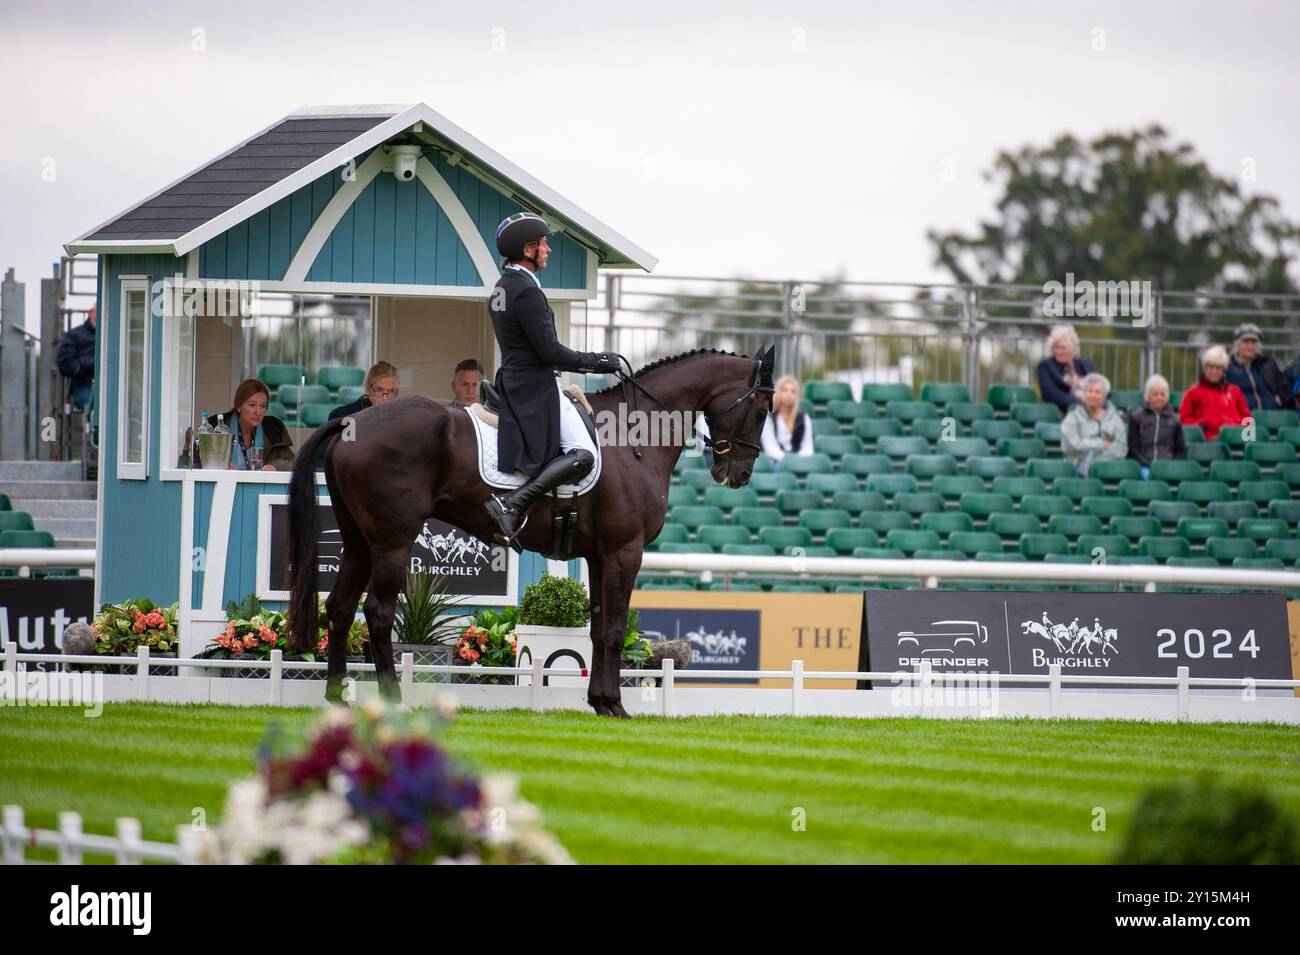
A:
289;347;772;717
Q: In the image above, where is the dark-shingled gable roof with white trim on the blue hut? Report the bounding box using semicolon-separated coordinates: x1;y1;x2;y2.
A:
65;103;657;272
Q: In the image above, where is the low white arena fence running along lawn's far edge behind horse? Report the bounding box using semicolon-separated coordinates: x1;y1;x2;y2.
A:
0;643;1300;724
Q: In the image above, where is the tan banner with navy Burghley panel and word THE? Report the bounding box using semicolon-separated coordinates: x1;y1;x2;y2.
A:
632;590;862;690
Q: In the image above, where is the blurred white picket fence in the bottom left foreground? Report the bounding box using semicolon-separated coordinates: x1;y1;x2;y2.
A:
0;806;194;865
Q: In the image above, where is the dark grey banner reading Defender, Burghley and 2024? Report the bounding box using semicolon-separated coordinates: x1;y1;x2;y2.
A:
862;590;1291;680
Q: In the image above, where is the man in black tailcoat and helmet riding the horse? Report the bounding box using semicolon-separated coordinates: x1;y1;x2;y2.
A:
484;212;619;550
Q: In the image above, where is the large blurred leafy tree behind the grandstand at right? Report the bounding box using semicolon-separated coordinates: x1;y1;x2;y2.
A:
927;125;1300;294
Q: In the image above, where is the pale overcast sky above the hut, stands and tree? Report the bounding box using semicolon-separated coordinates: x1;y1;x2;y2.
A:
0;0;1300;327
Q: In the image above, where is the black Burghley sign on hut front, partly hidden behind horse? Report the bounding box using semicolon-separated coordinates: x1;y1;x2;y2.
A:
257;495;519;604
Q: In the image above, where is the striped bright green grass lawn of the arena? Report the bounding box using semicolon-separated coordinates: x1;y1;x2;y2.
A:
0;704;1300;863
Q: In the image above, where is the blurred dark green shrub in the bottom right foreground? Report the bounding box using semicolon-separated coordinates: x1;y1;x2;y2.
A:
1115;777;1300;865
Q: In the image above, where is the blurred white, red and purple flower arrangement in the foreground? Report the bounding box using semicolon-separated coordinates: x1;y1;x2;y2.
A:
199;703;572;864
